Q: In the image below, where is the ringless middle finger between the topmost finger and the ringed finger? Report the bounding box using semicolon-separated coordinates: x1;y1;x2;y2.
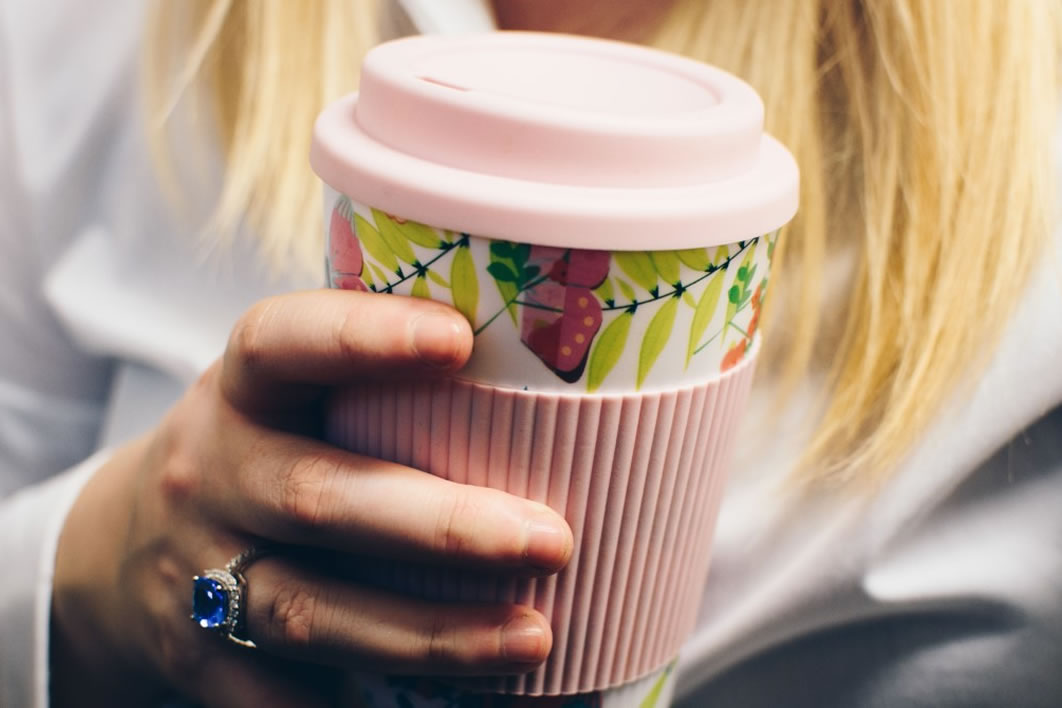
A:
207;425;573;573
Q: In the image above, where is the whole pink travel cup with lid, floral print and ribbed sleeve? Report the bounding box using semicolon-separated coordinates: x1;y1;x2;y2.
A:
311;33;798;708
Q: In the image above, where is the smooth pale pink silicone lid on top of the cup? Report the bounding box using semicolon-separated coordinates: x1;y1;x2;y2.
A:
310;32;799;251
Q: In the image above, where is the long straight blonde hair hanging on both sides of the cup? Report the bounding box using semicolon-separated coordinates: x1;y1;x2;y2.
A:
149;0;1060;484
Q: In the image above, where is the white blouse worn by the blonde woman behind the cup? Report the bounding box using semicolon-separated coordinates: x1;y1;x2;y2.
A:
0;0;1062;708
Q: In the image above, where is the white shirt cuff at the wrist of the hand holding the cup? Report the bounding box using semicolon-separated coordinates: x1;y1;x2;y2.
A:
0;451;107;708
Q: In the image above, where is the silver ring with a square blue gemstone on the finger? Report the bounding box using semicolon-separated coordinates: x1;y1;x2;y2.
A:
191;546;273;649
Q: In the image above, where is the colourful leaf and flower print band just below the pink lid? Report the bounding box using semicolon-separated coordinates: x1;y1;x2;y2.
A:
327;195;777;392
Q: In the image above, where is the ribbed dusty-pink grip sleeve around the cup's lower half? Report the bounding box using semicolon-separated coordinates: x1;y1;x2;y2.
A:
328;357;755;695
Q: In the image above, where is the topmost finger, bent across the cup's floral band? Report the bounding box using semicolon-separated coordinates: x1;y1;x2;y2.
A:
220;290;473;414
